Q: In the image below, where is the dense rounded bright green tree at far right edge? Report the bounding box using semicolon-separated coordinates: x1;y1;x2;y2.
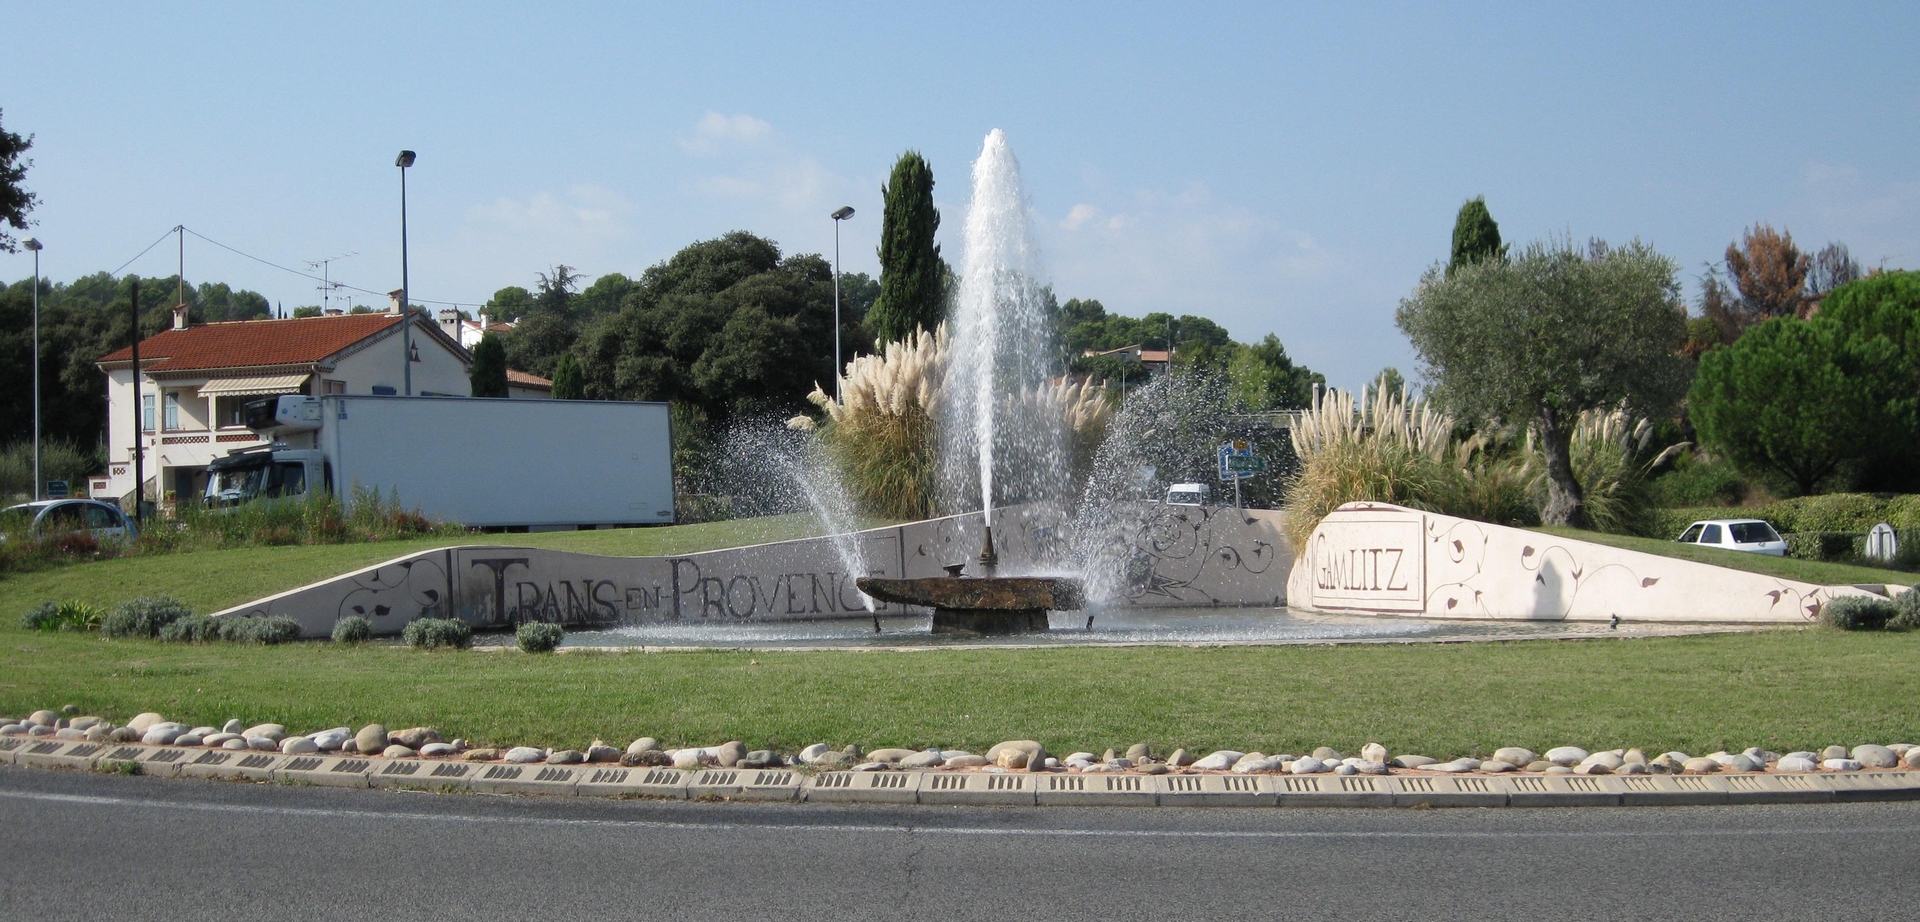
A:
1688;317;1914;494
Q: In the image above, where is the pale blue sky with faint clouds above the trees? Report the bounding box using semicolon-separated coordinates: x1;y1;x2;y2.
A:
0;2;1920;388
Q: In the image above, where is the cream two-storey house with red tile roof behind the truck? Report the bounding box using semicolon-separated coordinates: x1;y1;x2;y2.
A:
88;307;474;509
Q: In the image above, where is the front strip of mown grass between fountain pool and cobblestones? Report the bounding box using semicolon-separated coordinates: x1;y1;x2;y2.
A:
0;626;1920;757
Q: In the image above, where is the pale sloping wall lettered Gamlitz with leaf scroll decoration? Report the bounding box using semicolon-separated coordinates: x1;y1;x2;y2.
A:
1288;503;1864;624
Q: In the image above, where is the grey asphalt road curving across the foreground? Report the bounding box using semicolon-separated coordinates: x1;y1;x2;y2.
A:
0;766;1920;922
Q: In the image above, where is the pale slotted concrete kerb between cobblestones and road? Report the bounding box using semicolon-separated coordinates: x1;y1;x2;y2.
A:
0;736;1920;807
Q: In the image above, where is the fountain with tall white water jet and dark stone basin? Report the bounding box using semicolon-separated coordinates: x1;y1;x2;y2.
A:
856;129;1083;634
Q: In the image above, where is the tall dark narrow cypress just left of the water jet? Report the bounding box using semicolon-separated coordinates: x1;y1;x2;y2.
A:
866;150;950;344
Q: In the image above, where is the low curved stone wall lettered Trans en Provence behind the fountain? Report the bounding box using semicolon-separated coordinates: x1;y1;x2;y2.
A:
215;503;1292;638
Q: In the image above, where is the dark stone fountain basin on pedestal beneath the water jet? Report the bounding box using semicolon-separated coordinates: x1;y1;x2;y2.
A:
856;576;1083;634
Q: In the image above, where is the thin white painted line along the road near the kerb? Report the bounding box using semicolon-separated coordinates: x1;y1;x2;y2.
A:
0;791;1920;839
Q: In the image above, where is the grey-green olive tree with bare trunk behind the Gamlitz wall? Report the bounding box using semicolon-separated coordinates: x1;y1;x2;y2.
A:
1394;240;1690;526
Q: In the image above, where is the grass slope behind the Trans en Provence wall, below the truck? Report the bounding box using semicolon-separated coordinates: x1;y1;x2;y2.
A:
0;515;856;624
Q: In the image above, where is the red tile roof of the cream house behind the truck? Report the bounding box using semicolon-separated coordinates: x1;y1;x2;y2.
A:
100;313;399;371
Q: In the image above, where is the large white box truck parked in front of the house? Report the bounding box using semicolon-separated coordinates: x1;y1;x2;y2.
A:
205;394;674;530
